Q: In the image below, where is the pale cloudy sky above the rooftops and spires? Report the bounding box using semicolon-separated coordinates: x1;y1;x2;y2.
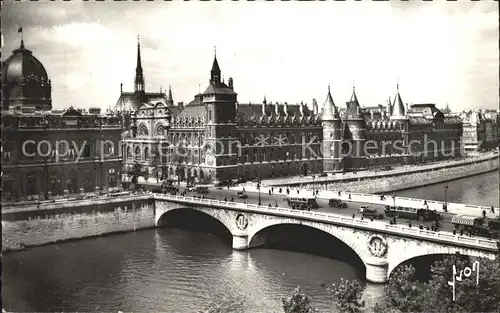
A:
1;0;499;111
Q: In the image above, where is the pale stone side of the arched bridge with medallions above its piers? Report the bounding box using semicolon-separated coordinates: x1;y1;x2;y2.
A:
153;194;498;283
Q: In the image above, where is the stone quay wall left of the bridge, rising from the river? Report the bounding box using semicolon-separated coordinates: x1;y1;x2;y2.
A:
2;196;155;252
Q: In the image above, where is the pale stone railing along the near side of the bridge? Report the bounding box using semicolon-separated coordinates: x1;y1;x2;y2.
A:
154;194;497;249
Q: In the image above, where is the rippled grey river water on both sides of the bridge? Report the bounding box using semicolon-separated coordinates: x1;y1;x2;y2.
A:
2;172;500;313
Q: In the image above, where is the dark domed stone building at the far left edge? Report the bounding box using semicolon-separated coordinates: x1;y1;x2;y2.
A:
1;40;122;201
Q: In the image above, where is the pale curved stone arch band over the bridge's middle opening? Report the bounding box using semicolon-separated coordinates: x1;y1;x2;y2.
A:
248;219;370;268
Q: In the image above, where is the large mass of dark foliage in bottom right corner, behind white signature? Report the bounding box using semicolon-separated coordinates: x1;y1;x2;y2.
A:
374;255;500;313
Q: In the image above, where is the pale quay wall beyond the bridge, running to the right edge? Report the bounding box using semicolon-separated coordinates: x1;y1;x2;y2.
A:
287;156;499;194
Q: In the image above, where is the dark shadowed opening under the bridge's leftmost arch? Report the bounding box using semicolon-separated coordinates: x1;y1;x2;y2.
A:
156;207;233;245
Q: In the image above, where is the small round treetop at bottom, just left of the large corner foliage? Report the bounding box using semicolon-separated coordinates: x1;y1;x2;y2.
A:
329;278;365;313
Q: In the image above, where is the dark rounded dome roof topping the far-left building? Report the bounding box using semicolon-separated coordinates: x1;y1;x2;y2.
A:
2;41;48;83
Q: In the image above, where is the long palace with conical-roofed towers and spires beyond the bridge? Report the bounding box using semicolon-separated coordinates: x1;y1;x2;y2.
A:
116;41;462;182
